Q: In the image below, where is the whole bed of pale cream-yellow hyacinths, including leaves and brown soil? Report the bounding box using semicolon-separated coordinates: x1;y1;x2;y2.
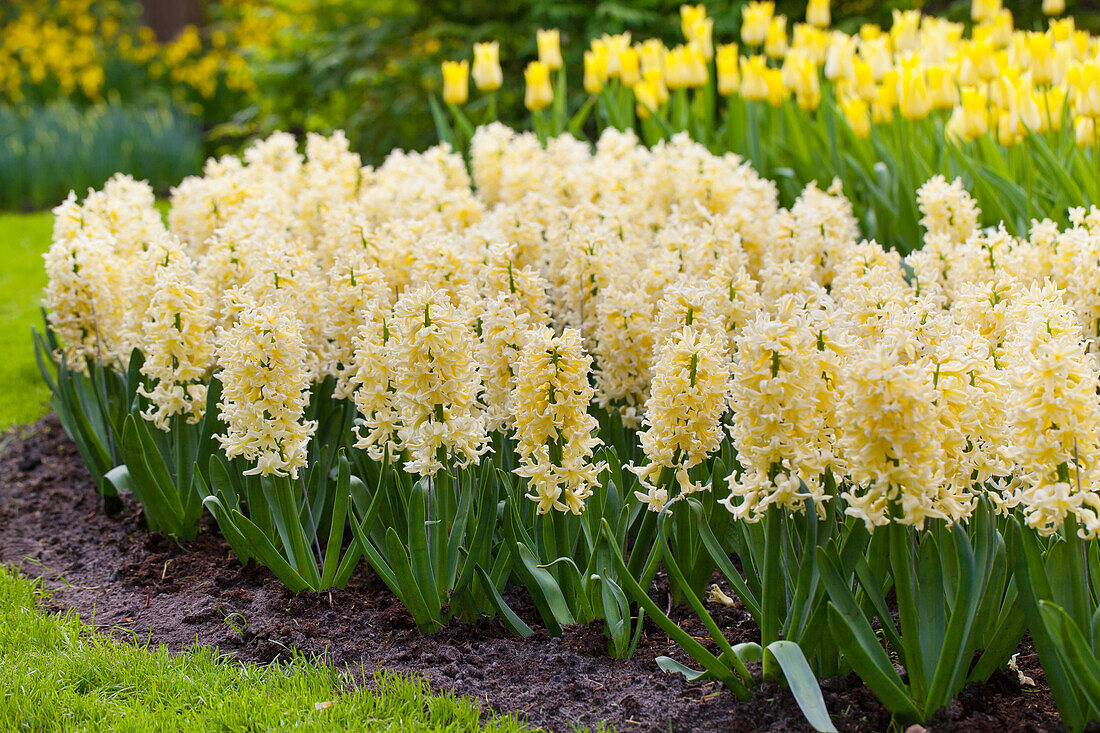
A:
4;117;1100;730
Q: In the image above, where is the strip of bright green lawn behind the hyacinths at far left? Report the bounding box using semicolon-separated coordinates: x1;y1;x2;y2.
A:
0;211;54;430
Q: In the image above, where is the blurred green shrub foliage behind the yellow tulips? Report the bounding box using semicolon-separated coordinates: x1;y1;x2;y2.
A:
238;0;1097;163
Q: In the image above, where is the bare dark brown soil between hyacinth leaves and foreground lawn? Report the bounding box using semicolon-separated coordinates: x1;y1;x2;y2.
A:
0;417;1062;732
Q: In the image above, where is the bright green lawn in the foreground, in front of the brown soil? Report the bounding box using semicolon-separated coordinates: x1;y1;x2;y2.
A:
0;566;526;733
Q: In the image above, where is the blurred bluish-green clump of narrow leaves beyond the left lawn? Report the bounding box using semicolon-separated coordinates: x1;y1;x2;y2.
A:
0;102;202;209
